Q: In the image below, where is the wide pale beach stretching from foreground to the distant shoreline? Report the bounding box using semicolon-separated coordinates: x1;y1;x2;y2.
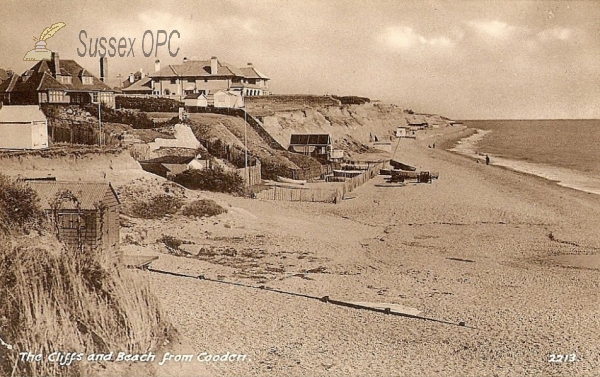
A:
129;128;600;376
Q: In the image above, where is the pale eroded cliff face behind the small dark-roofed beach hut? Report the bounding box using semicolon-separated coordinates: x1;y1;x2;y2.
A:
262;102;447;149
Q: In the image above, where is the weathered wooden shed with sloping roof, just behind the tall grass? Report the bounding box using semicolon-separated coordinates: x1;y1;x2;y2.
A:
26;180;121;261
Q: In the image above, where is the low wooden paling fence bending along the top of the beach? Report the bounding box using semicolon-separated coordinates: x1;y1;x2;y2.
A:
252;161;386;203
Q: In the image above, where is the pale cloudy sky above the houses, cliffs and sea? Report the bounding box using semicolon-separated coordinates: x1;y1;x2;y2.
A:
0;0;600;119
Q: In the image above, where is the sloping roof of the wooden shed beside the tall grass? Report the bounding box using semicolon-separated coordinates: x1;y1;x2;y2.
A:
26;181;120;210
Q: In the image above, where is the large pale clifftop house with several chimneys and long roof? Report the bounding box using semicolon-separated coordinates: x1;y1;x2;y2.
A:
149;56;270;100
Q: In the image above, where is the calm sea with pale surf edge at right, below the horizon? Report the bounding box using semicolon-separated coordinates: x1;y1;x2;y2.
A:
451;119;600;195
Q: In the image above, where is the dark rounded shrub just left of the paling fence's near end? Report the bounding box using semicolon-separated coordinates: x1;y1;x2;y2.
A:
173;166;244;195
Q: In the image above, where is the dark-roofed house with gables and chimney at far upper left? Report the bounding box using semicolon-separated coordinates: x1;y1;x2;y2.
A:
0;52;115;107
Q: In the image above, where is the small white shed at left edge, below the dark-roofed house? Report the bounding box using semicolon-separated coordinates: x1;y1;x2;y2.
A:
0;105;48;149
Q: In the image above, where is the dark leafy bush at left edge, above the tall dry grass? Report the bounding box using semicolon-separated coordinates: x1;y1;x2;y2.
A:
0;174;44;231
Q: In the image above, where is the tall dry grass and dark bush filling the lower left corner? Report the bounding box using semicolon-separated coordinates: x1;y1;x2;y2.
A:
0;175;169;376
